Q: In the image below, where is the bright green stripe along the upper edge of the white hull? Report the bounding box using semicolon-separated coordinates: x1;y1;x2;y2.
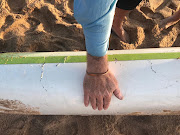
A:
0;52;180;64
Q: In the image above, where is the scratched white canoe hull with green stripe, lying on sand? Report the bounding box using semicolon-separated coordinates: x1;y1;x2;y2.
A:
0;47;180;115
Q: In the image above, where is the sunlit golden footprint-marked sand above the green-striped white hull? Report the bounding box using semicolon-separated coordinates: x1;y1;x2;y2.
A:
0;0;180;52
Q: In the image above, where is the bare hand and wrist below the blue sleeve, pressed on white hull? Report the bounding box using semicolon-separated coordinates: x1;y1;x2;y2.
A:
83;54;123;110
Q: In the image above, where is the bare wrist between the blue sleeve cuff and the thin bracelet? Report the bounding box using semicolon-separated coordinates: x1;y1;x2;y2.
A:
87;53;108;73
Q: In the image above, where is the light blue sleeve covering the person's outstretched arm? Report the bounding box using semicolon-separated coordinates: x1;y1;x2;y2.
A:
74;0;117;57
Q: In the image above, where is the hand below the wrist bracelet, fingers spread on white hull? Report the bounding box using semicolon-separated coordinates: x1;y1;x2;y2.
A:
83;71;123;110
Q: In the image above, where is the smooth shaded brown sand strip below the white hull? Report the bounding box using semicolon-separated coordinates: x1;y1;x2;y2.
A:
0;114;180;135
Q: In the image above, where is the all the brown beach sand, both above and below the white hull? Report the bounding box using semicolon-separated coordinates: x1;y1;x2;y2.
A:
0;0;180;135
